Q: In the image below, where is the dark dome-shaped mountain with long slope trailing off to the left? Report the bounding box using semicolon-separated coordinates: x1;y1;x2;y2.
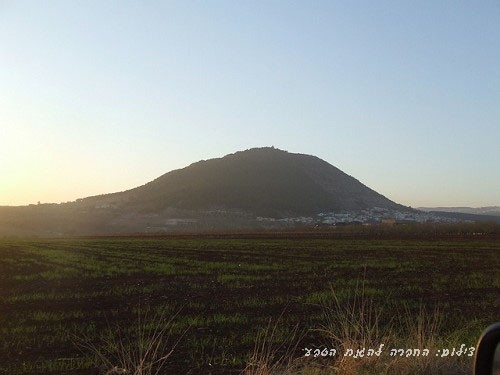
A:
0;147;410;234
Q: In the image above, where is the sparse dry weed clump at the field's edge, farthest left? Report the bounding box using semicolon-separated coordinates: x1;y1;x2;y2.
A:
75;309;188;375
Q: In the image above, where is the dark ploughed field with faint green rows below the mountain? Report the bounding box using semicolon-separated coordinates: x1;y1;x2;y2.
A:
0;238;500;374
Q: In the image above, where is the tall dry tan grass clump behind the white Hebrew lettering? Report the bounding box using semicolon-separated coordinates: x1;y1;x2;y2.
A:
318;283;471;375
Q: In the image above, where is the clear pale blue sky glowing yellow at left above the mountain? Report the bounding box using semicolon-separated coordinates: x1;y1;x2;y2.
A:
0;0;500;207
